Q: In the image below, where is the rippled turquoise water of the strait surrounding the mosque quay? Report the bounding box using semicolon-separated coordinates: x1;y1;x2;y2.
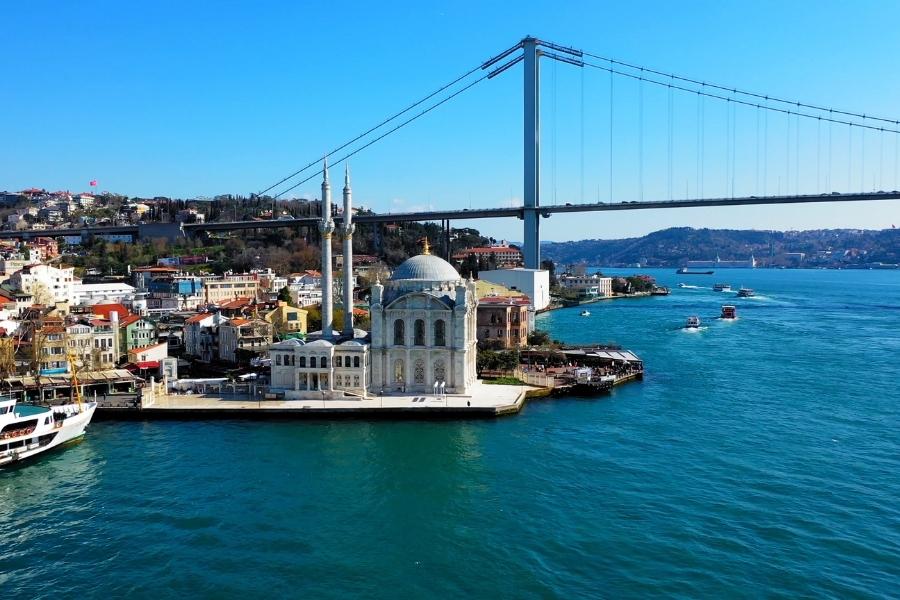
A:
0;270;900;598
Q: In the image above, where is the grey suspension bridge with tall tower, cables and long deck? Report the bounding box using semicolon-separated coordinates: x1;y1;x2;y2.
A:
8;37;900;268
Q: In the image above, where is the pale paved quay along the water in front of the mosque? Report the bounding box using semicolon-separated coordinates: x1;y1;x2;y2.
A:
141;381;539;417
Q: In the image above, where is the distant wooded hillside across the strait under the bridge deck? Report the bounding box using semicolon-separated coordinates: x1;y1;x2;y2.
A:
541;227;900;267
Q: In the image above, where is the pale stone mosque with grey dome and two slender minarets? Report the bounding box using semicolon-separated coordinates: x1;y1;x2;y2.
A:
269;163;478;400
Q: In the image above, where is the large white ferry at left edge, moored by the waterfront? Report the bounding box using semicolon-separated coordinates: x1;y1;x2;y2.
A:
0;398;97;468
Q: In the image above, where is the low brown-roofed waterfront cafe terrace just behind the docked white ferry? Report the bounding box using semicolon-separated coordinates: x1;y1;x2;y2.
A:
0;369;144;404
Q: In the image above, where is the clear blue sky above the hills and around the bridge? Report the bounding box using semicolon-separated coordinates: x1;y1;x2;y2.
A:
0;1;900;240
